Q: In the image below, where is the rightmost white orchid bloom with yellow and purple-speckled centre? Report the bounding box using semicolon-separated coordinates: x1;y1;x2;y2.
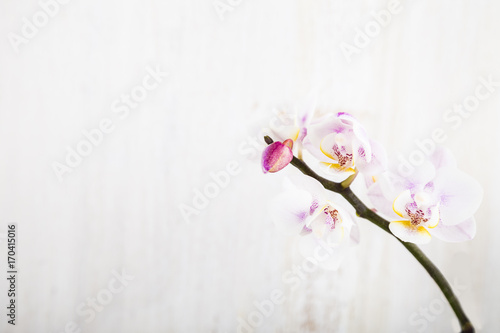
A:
368;148;483;244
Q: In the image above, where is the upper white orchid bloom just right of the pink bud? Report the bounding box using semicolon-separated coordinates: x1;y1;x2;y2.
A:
304;112;386;184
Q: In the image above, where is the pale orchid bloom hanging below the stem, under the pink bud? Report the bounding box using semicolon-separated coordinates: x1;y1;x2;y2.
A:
270;177;359;270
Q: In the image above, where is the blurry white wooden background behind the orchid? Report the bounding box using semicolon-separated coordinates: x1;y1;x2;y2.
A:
0;0;500;333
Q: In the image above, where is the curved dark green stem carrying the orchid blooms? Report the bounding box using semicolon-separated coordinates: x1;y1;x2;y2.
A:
264;136;474;333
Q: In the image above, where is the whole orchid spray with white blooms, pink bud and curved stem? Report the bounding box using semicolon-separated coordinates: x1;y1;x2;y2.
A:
262;107;483;332
